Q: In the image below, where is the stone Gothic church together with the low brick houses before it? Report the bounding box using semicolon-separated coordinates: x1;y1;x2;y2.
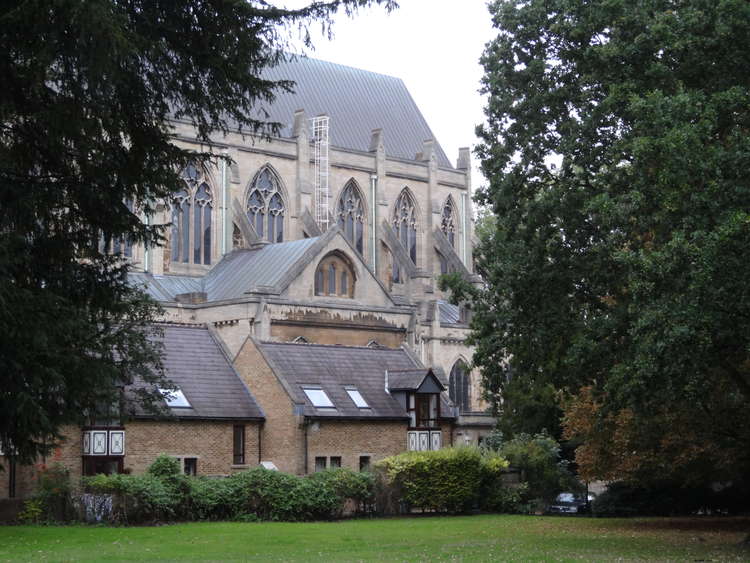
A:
0;58;494;498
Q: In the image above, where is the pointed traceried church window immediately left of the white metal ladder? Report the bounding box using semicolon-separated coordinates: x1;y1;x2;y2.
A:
245;168;285;242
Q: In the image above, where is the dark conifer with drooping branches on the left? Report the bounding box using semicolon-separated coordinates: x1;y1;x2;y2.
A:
0;0;395;461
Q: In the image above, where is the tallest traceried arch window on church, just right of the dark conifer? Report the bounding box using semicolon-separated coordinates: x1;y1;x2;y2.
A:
170;164;213;264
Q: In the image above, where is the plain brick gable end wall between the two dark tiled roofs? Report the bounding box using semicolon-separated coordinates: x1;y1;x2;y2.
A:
234;339;304;474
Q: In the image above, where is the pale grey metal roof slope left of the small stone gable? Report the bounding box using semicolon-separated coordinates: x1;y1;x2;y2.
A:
202;237;320;301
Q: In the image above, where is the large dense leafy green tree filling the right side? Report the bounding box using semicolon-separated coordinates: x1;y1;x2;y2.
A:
454;0;750;479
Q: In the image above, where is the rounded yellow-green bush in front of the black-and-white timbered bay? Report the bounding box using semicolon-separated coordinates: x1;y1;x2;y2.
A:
376;447;508;512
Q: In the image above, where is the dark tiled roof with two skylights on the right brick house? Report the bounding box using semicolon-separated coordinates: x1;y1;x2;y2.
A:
258;342;422;419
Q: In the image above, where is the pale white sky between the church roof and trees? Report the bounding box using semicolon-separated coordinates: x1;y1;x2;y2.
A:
274;0;494;188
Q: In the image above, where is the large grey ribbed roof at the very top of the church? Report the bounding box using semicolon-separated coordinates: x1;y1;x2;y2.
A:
262;57;453;172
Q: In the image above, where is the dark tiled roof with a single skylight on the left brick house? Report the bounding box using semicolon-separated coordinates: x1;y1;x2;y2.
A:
131;325;263;420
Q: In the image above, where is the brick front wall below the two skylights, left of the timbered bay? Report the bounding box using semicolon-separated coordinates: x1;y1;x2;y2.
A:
307;420;407;472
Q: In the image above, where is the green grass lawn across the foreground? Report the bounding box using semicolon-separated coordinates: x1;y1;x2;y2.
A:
0;516;750;562
